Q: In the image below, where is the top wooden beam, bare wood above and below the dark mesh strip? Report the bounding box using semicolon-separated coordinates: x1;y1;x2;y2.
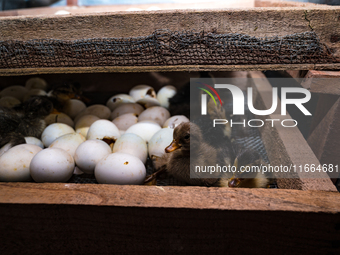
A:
0;1;340;75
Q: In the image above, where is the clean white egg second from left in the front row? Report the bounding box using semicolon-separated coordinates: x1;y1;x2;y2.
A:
30;148;75;182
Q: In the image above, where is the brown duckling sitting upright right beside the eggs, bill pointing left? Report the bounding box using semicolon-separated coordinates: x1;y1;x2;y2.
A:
148;122;233;186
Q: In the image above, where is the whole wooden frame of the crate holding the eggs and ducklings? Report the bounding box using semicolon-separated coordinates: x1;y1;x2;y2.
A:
0;1;340;254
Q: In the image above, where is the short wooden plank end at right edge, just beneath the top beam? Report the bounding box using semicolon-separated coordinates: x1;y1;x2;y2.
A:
301;70;340;95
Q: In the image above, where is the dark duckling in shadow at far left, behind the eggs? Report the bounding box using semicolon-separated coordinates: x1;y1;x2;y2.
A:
0;96;53;148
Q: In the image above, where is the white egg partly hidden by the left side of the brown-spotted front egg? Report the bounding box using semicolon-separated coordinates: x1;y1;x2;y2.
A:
74;140;111;174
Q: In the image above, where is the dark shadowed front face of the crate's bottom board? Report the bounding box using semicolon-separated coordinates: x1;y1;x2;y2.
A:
0;201;340;255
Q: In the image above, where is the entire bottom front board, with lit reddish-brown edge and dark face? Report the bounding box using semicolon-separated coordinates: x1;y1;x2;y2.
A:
0;183;340;255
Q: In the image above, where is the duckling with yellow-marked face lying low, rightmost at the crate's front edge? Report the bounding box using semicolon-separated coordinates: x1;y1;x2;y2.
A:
218;149;275;188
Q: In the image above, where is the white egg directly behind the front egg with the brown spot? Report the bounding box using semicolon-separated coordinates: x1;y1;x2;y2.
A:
113;133;148;164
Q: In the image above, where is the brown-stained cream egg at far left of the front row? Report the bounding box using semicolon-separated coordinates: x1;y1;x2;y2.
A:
0;144;42;182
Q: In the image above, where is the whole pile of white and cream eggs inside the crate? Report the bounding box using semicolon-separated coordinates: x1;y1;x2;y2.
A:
0;78;189;184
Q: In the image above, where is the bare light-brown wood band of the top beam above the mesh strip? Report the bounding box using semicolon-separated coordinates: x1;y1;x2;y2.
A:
0;6;340;58
